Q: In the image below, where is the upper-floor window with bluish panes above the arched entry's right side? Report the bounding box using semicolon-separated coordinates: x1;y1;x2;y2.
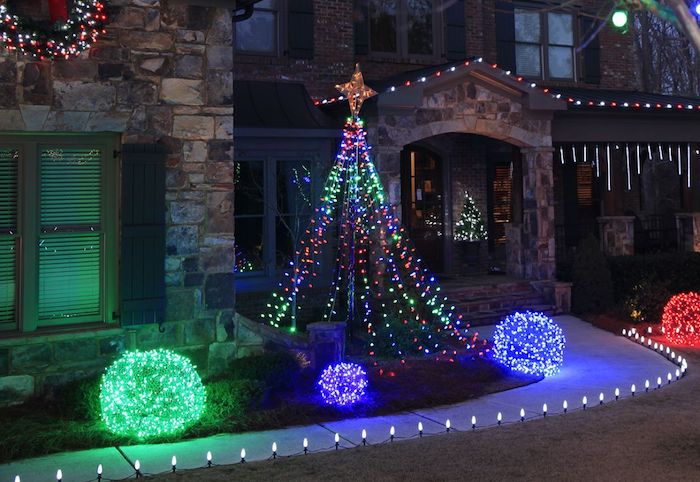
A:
514;8;574;80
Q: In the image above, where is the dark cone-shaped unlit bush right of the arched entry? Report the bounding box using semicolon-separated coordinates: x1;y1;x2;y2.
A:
571;235;613;313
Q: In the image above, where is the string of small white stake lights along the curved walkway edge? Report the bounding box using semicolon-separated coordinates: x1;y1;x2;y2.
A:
15;328;688;482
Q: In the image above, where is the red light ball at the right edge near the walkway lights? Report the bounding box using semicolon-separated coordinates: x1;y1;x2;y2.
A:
661;291;700;346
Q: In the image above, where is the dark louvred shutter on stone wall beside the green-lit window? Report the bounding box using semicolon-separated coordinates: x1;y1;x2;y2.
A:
120;144;165;326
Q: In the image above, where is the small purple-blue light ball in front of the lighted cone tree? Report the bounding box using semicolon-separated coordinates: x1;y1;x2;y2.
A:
316;363;367;407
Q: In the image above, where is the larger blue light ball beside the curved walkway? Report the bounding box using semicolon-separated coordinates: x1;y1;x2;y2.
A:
493;311;566;377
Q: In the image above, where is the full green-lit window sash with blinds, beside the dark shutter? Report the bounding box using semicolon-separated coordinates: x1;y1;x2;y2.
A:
38;147;104;326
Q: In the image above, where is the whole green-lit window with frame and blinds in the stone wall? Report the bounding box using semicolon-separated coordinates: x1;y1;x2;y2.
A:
0;135;118;331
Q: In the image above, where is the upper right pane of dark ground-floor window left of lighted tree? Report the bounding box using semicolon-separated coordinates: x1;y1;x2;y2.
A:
277;161;315;214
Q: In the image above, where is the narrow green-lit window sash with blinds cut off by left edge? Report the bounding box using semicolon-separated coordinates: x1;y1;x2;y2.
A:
0;148;19;329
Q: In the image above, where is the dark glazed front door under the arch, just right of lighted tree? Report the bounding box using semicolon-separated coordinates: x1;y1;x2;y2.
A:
401;148;445;272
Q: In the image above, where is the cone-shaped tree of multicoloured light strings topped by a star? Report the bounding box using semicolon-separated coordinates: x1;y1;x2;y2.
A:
262;67;473;359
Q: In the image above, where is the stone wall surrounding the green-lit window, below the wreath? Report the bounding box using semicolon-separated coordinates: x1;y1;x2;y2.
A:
0;0;237;404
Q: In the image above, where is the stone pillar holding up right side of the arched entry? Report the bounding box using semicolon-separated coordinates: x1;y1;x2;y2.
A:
521;147;556;279
